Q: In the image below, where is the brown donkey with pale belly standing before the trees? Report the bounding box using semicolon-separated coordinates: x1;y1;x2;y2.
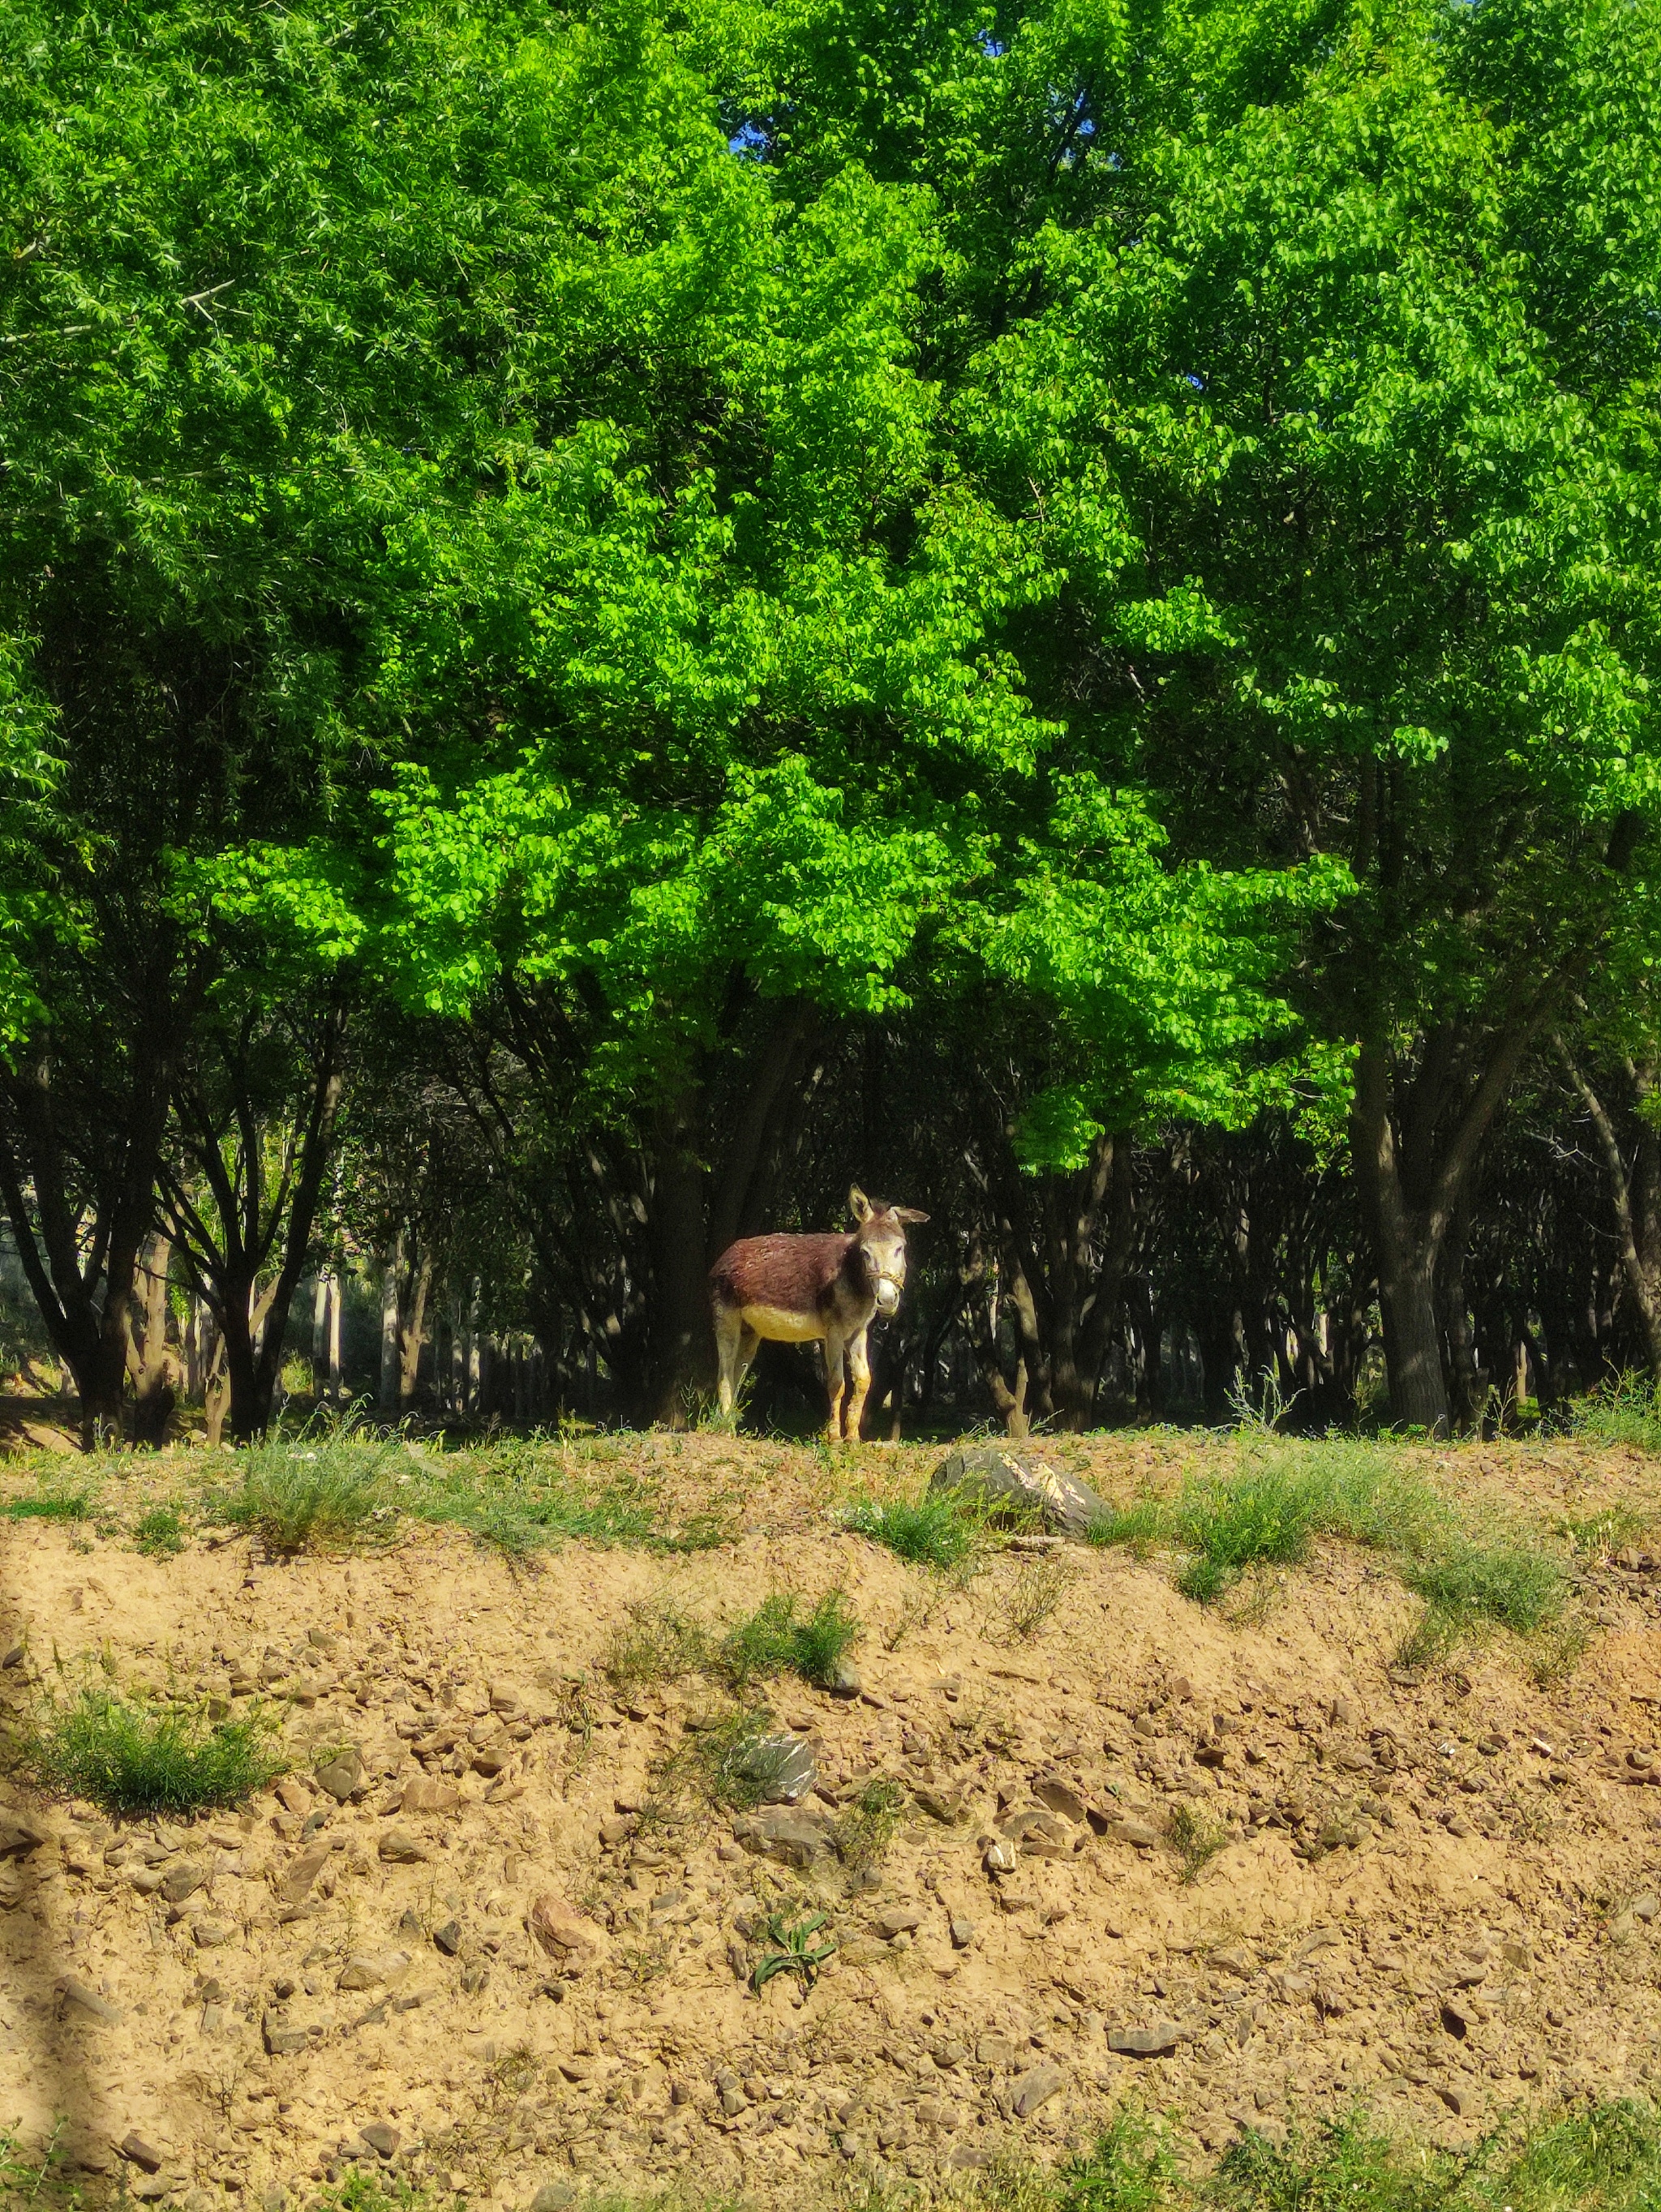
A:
710;1183;929;1443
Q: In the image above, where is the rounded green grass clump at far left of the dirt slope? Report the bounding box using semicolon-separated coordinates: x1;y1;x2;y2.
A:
20;1687;288;1818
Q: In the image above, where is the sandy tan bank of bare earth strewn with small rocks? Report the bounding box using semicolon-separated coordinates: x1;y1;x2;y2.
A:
0;1443;1661;2212
